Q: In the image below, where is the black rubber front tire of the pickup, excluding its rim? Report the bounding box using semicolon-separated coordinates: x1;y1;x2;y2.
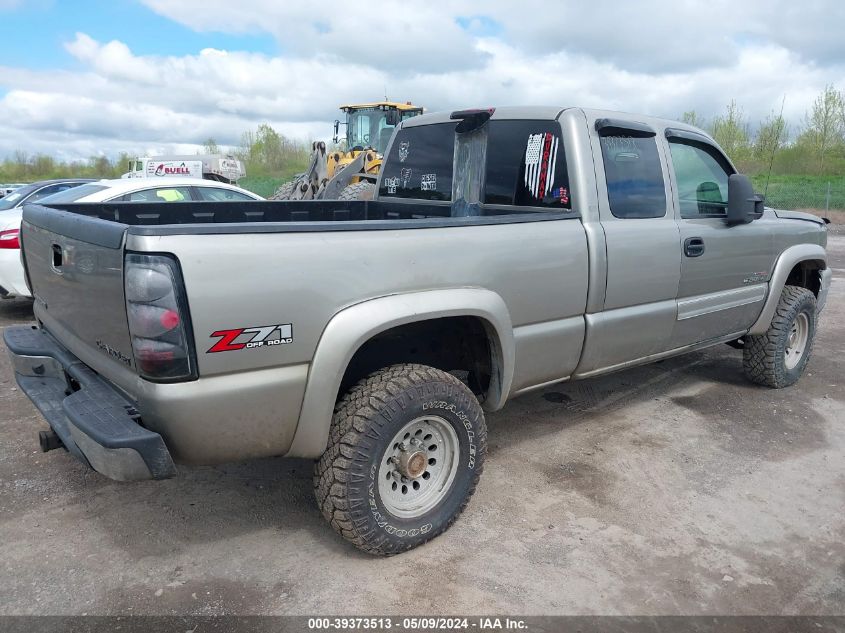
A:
742;286;816;389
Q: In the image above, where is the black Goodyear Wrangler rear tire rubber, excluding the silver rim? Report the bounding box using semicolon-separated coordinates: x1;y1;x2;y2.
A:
314;364;487;556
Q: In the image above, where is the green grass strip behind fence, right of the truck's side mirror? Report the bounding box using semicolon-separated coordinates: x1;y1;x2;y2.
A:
751;173;845;210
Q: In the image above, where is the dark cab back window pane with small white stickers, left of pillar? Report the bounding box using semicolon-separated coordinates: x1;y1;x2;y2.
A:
379;122;455;200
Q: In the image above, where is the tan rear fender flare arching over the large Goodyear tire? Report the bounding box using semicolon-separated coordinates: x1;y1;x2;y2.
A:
286;288;514;458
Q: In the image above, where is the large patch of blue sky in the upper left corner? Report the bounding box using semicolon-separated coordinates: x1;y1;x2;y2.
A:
0;0;274;69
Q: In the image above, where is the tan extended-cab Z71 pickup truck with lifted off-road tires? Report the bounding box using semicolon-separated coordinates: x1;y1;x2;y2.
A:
5;107;830;554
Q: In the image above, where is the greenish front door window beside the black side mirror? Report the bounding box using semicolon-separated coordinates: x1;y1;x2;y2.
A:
669;141;733;218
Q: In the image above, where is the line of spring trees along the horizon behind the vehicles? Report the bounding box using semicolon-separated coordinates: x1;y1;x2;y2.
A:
0;85;845;182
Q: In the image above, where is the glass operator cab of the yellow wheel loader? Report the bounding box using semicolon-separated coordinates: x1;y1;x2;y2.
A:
335;101;423;155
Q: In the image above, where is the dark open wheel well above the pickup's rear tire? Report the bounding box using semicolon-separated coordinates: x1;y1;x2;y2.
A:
338;316;493;401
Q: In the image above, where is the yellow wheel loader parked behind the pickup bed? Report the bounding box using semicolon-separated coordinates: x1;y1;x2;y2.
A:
271;101;423;200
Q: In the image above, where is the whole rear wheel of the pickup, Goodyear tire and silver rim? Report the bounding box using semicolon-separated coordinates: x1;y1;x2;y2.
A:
314;364;487;555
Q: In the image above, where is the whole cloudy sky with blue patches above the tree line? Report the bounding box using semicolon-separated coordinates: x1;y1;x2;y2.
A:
0;0;845;159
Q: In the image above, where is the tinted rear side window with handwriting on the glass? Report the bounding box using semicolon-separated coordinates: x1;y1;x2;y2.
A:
601;135;666;218
